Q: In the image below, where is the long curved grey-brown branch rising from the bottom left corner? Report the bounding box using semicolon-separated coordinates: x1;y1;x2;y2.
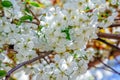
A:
5;51;53;80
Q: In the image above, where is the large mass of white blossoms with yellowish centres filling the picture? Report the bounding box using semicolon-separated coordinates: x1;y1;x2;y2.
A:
0;0;120;80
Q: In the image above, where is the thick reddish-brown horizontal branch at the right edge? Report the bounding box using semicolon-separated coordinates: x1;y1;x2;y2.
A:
97;33;120;39
